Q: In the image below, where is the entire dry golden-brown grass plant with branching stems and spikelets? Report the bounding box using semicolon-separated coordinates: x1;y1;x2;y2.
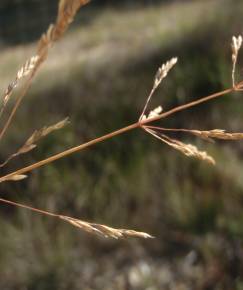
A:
0;0;243;239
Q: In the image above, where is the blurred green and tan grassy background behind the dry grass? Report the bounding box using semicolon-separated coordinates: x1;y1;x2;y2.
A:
0;0;243;290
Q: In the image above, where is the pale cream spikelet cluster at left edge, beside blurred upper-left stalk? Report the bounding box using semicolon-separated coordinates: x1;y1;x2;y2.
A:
0;56;39;116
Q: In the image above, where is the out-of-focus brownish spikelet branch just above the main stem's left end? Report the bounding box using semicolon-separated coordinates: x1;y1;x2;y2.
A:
0;118;69;167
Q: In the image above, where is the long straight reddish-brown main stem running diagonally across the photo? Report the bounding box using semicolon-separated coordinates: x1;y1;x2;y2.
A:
0;88;234;182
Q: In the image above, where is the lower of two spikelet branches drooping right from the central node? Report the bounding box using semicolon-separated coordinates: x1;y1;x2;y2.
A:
143;127;215;165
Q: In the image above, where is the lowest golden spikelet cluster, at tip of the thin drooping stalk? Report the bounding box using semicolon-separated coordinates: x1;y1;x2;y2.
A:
59;215;153;239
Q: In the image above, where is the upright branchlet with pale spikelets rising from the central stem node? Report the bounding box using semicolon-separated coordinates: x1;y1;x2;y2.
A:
139;57;178;121
